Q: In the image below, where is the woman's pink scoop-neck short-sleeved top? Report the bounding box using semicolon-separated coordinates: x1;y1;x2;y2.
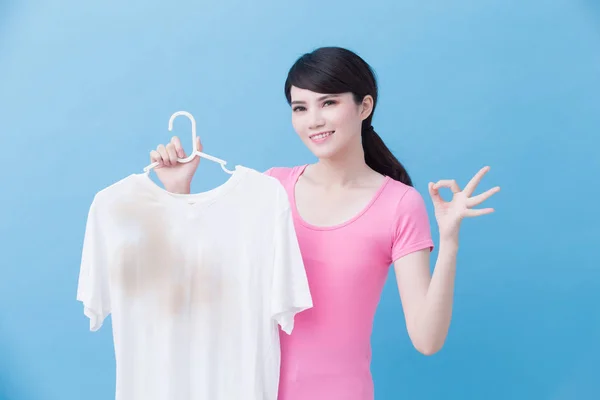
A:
266;165;433;400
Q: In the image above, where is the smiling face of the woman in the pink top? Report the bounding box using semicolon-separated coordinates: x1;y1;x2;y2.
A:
290;86;372;159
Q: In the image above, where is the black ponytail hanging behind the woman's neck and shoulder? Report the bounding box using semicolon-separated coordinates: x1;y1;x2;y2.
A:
361;125;413;186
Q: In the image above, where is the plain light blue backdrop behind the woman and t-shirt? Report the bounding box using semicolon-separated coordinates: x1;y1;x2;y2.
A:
0;0;600;400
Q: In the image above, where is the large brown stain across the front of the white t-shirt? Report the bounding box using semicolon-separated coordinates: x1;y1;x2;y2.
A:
106;194;231;316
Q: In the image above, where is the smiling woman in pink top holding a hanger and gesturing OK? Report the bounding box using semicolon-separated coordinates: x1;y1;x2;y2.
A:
150;47;499;400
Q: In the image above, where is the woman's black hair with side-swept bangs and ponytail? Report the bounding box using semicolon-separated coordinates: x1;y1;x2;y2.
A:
285;47;412;186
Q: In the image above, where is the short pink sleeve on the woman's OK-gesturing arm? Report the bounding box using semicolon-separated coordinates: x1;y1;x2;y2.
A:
392;188;434;262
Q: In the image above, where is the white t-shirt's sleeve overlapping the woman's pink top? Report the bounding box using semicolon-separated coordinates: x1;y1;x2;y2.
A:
271;188;313;335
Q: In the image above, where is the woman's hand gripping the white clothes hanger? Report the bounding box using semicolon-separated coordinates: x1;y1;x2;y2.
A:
150;136;202;193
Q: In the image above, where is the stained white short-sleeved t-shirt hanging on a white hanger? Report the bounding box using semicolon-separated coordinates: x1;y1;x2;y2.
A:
77;166;312;400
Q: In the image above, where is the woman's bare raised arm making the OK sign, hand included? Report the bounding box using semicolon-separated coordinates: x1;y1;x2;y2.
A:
394;167;500;355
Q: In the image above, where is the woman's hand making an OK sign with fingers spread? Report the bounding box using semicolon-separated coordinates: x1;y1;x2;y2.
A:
429;167;500;238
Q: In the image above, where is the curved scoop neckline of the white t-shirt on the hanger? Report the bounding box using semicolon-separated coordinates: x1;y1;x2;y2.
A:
136;165;246;210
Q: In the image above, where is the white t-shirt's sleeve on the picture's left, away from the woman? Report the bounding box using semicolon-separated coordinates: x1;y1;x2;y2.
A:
77;198;111;331
